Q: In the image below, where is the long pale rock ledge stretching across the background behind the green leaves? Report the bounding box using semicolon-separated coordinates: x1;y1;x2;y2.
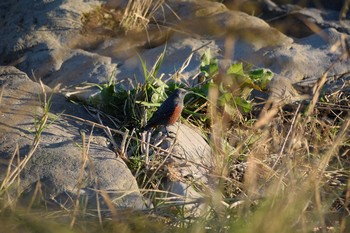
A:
0;0;350;104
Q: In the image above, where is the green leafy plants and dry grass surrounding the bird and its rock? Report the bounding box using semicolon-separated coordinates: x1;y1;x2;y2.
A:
0;0;350;233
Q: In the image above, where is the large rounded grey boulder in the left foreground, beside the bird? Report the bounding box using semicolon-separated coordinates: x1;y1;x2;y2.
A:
0;67;145;210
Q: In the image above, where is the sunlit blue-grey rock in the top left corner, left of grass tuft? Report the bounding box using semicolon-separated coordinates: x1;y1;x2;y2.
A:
0;0;116;87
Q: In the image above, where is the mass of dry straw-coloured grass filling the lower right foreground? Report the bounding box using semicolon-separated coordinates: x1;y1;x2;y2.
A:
58;48;350;232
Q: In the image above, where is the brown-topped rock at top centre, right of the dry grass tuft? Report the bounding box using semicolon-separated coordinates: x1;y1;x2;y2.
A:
87;1;293;88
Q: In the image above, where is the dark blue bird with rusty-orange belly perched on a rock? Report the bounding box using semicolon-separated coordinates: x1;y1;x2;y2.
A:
143;88;188;130
